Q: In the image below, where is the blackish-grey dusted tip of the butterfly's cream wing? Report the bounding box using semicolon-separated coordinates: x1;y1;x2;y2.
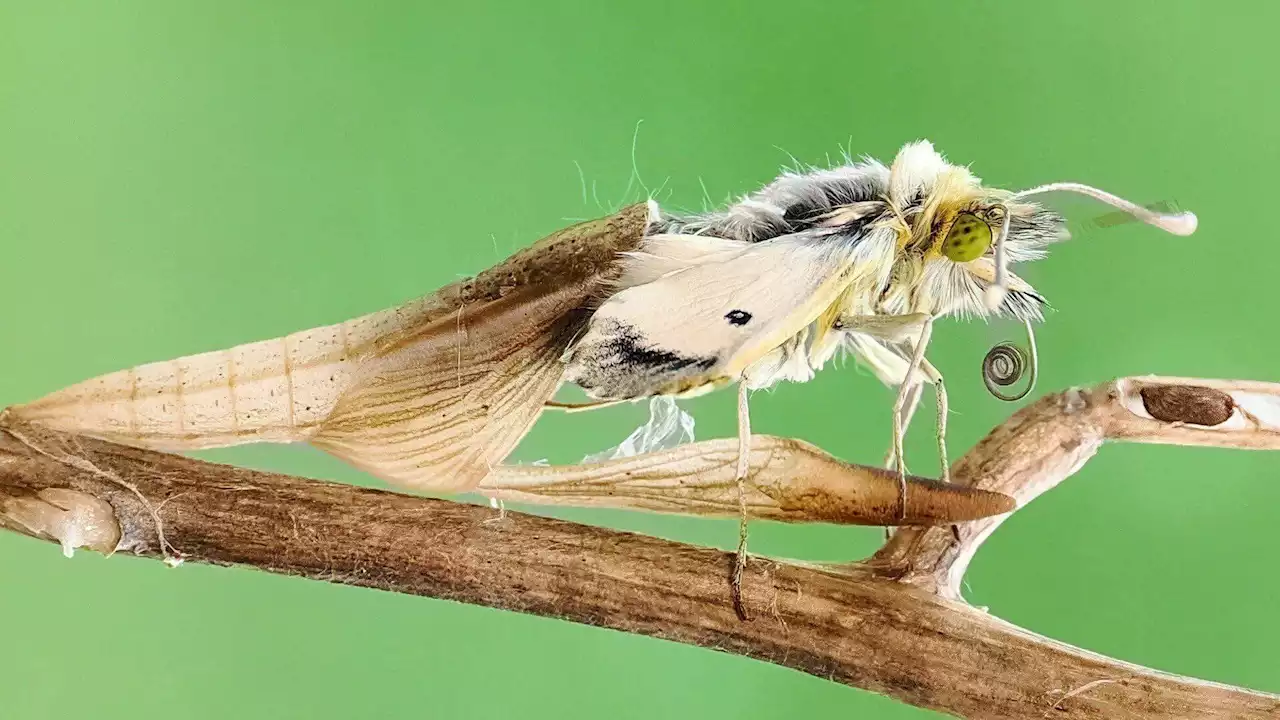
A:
564;318;719;400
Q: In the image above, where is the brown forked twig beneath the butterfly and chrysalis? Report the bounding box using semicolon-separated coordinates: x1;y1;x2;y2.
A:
0;379;1280;719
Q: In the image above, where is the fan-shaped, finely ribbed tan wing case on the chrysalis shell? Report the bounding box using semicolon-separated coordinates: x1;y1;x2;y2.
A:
311;278;589;491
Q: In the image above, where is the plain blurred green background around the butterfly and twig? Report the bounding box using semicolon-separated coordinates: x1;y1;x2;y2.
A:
0;0;1280;719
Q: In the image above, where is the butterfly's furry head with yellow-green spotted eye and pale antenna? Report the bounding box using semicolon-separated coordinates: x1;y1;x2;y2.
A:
886;141;1196;313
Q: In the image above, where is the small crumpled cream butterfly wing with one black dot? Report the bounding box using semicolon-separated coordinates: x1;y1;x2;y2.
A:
566;236;852;398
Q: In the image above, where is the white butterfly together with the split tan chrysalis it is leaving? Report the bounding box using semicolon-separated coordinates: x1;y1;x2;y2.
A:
12;141;1196;617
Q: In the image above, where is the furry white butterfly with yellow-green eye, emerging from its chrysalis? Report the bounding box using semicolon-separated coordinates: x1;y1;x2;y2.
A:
566;142;1196;599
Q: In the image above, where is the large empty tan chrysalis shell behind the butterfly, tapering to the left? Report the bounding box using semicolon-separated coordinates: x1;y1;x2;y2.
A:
12;205;650;489
